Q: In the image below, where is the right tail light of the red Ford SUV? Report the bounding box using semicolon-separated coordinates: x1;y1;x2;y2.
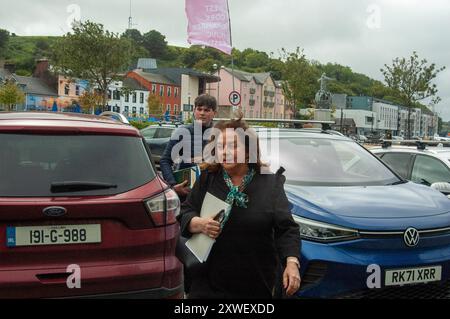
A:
145;189;180;226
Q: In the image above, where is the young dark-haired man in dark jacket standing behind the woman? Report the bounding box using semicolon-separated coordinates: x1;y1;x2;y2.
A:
160;94;217;201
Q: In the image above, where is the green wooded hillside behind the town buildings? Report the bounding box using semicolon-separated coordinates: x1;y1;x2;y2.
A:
0;30;432;115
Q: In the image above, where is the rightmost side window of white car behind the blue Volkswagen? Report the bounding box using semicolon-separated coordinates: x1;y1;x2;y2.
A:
411;155;450;185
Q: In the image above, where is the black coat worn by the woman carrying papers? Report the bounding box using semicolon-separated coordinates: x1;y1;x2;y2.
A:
179;170;301;298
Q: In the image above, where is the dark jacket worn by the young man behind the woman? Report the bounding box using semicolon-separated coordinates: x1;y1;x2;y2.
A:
159;124;212;186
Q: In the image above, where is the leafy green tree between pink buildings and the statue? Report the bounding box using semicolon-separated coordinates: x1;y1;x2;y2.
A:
282;48;320;117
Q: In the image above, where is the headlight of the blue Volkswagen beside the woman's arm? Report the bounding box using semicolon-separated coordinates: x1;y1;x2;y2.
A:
292;215;359;242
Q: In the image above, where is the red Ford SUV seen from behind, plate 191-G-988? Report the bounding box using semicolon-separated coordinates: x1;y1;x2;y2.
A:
0;112;183;298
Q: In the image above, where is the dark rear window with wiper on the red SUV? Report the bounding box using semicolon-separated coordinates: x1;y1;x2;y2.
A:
0;134;156;197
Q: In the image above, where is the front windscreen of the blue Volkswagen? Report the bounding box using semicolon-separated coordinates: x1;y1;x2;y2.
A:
267;137;400;186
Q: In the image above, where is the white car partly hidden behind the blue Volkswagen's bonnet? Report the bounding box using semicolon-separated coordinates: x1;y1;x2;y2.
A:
370;145;450;192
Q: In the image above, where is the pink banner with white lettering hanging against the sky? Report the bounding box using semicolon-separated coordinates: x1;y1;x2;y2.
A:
186;0;231;54
